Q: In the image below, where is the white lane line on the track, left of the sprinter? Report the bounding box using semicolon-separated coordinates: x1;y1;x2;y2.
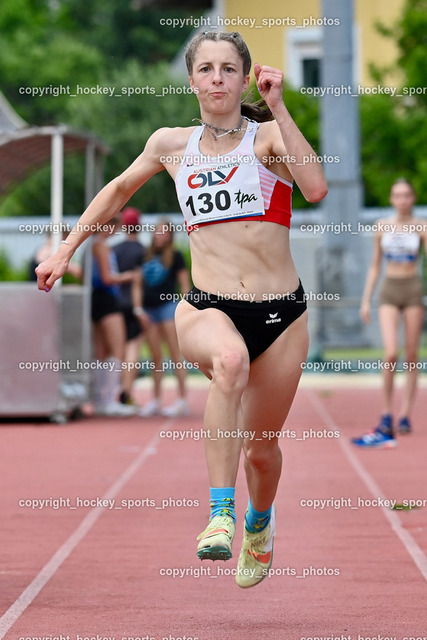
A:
0;419;171;640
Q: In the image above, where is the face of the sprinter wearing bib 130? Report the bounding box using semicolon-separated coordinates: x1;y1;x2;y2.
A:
190;40;249;113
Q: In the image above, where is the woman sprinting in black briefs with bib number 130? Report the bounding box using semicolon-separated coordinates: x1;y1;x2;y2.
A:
37;31;327;587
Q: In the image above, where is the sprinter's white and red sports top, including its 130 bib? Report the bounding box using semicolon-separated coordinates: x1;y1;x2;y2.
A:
175;120;292;233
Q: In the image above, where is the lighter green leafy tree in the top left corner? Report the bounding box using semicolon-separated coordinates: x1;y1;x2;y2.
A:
0;0;104;125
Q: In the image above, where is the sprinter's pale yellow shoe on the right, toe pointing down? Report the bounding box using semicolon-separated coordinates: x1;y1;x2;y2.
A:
236;505;276;588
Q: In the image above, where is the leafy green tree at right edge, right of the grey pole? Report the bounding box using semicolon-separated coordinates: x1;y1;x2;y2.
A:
361;0;427;206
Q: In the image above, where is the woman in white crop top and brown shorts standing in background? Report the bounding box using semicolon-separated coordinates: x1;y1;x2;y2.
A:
353;178;427;447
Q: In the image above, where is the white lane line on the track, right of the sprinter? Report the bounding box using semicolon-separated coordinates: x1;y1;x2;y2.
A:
305;391;427;580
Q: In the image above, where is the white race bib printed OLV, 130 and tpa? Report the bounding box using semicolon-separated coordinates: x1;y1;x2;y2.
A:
178;154;265;226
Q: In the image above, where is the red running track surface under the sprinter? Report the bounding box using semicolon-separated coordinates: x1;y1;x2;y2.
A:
0;380;427;640
